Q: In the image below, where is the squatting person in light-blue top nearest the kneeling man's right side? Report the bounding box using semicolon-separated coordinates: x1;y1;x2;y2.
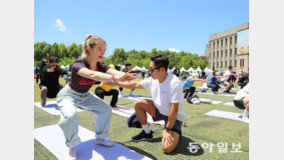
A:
181;75;204;99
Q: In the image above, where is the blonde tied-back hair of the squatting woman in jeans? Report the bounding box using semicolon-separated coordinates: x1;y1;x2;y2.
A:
81;34;106;58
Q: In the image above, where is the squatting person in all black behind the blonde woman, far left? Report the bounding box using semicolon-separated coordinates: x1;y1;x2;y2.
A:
39;57;70;106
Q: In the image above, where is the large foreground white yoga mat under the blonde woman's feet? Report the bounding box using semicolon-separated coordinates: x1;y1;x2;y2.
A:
34;125;153;160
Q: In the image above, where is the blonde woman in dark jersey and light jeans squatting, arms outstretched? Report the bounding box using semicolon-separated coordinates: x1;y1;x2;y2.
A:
57;35;136;159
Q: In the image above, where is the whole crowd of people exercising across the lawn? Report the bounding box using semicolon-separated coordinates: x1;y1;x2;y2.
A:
36;35;249;159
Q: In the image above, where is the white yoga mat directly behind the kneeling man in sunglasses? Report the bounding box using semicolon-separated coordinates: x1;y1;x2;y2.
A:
112;106;165;125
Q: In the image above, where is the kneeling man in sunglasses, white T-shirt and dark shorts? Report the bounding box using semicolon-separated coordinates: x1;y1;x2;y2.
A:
105;54;185;153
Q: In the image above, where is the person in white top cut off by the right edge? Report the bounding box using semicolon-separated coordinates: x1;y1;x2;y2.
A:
234;83;249;118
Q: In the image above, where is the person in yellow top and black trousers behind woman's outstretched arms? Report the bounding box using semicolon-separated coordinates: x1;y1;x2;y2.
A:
95;64;119;107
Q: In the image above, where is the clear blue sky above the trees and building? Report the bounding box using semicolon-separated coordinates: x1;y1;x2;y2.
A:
34;0;249;56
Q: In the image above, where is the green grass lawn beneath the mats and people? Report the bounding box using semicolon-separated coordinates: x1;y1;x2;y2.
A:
34;79;249;160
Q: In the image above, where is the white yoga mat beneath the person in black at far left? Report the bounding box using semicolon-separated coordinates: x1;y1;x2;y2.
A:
34;101;84;115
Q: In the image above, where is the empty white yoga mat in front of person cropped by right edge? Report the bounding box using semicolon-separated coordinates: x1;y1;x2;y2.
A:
205;110;248;123
